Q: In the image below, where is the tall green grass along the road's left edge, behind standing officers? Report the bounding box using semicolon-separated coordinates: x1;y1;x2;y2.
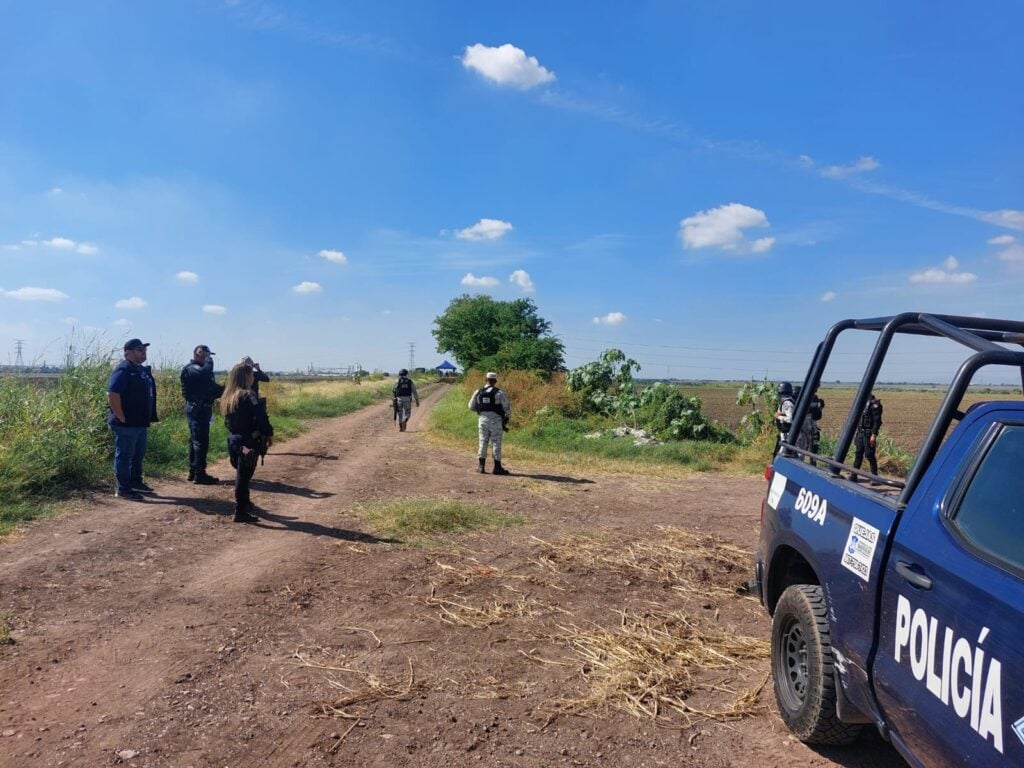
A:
0;360;391;535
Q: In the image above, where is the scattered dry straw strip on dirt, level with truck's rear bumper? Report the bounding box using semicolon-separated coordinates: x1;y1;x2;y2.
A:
535;525;751;595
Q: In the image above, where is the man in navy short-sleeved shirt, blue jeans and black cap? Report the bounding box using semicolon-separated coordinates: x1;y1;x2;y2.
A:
106;339;158;502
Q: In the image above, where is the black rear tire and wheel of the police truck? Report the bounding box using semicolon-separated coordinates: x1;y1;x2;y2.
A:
771;584;861;744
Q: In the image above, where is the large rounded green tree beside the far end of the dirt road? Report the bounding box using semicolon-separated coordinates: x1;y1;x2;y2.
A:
431;294;565;374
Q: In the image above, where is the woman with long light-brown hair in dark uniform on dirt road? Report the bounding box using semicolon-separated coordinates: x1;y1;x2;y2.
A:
220;362;273;522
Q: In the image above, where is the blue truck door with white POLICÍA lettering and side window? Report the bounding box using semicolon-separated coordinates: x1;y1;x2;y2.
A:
873;421;1024;768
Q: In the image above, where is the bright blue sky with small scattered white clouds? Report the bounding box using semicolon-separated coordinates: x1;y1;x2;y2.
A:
0;0;1024;381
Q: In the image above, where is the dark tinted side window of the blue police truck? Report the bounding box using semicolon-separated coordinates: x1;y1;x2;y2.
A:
952;425;1024;570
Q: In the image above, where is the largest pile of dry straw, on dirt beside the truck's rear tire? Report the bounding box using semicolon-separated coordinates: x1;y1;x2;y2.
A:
551;610;769;727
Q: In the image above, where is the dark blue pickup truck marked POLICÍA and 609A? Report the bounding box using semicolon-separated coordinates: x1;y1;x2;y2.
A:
752;312;1024;768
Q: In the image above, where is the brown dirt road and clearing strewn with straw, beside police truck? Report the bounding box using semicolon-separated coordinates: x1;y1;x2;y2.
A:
0;390;903;768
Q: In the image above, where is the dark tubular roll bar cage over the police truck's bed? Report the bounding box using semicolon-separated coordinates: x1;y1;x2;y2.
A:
780;312;1024;509
